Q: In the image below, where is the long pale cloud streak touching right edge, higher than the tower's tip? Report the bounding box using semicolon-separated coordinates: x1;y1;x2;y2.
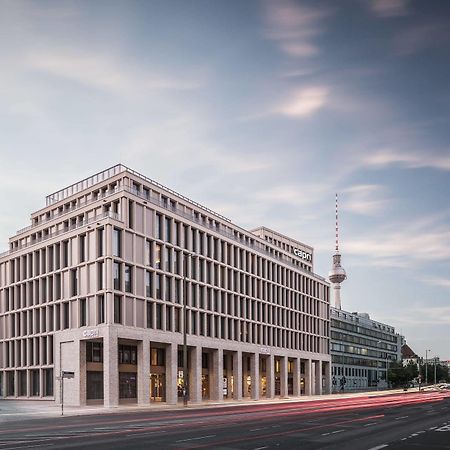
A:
361;149;450;171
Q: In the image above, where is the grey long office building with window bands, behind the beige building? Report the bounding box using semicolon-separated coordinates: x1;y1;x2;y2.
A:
330;307;402;391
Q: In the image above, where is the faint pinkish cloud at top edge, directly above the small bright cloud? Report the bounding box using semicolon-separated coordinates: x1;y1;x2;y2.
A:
265;0;330;58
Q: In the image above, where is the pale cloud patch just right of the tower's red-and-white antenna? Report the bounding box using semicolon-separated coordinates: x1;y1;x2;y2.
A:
342;184;390;216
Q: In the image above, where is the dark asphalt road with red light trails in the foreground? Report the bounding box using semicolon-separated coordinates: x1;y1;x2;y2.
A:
0;392;450;450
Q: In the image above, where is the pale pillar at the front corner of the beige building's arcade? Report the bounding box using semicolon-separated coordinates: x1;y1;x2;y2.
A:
103;328;119;407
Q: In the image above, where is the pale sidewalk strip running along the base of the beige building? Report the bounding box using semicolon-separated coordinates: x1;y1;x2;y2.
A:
0;388;418;427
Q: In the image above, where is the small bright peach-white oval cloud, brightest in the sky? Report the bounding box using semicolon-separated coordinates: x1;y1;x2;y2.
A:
277;86;328;118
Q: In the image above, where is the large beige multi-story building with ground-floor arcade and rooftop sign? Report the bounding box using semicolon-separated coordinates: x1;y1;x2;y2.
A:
0;165;331;406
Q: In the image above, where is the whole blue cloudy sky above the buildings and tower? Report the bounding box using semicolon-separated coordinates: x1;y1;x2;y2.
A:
0;0;450;359
